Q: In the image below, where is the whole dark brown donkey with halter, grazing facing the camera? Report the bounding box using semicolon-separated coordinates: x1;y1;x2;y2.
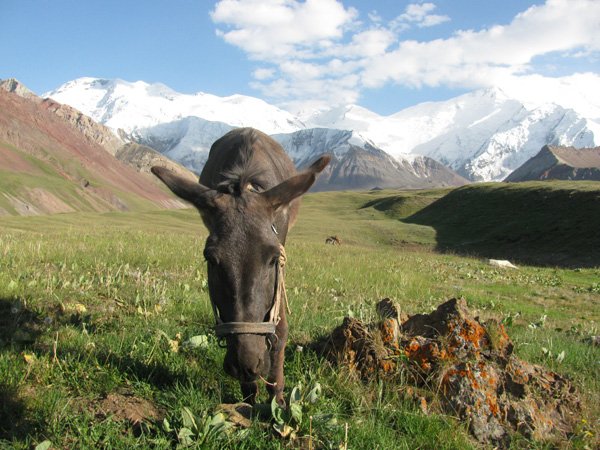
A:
152;128;331;407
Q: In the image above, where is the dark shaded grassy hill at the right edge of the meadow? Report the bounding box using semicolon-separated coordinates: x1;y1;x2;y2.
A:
404;181;600;266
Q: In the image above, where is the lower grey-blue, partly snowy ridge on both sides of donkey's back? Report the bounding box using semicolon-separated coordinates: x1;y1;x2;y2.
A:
125;111;469;190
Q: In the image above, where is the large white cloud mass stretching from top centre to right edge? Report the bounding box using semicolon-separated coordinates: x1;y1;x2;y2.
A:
212;0;600;112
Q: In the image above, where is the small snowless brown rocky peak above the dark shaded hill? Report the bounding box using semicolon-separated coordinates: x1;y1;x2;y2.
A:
505;145;600;182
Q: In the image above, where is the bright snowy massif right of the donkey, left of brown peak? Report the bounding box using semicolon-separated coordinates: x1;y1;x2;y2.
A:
303;88;600;181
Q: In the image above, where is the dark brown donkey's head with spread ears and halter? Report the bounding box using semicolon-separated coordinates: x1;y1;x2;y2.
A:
152;156;330;382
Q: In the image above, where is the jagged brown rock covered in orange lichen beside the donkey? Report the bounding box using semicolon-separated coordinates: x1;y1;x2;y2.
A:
321;299;581;447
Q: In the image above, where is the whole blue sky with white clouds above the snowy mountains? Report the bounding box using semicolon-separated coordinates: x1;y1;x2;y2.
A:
0;0;600;115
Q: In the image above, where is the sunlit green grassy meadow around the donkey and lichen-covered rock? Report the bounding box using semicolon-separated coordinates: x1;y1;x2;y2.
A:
0;184;600;450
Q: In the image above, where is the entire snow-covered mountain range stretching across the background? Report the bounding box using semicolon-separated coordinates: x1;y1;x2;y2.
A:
44;78;600;183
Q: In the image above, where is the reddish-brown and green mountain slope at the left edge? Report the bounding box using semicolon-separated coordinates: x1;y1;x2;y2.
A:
0;82;186;215
